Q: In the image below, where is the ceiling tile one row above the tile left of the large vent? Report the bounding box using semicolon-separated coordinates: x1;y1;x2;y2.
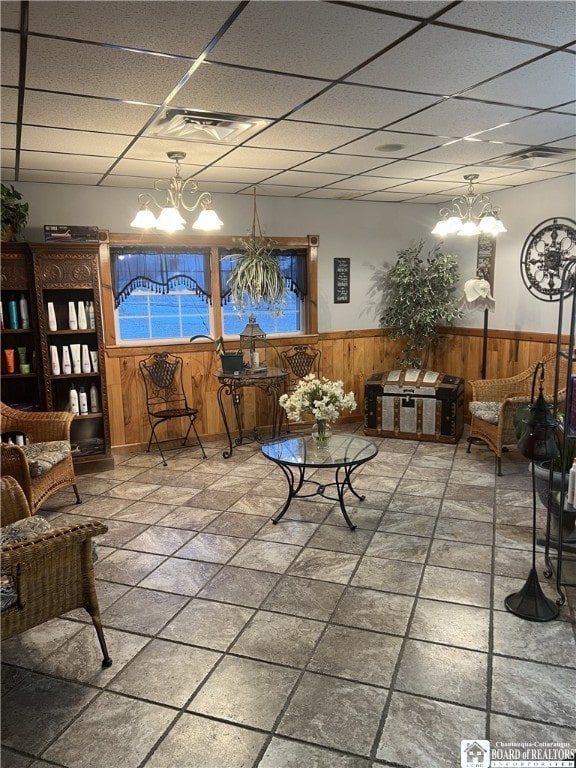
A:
26;37;190;104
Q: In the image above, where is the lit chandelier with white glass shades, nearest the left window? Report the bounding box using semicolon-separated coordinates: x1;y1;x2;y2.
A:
130;152;224;232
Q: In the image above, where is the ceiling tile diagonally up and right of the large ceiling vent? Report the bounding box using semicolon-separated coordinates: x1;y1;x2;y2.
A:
292;84;437;128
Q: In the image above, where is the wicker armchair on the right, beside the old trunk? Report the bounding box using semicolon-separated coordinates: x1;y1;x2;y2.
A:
467;352;567;476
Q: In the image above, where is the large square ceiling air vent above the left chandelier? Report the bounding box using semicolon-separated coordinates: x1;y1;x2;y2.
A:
145;108;271;144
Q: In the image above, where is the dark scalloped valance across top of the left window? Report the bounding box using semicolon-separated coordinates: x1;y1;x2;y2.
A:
110;245;212;308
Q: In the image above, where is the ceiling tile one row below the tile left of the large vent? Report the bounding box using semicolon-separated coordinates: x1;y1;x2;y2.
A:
22;125;130;156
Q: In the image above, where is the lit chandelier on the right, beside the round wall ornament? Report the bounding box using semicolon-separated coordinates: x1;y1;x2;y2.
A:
432;173;507;237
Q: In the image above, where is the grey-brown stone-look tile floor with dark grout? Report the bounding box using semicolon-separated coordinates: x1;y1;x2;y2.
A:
2;425;576;768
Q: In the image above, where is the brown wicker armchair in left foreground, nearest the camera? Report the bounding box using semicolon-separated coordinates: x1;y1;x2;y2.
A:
0;477;112;667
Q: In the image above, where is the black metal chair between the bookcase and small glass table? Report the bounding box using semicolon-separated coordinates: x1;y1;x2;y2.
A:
140;352;206;466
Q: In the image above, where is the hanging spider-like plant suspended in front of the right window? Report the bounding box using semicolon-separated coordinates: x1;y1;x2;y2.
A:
228;188;287;315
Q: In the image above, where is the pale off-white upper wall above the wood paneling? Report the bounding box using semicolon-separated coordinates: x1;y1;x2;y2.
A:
14;176;576;333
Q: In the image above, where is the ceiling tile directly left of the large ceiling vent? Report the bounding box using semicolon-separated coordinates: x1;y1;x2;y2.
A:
24;90;155;134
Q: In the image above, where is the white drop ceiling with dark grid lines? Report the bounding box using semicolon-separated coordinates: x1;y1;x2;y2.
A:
0;0;576;204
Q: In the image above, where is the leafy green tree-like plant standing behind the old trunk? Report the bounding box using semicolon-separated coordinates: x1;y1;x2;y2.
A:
377;240;462;368
